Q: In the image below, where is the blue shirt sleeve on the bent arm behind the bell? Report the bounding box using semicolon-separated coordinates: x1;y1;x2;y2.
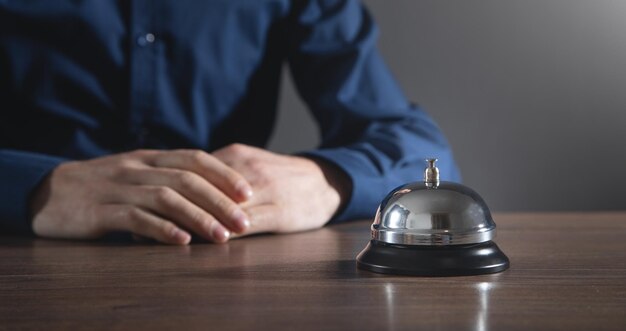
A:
288;0;460;223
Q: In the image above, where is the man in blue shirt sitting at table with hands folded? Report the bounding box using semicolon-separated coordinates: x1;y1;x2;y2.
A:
0;0;458;244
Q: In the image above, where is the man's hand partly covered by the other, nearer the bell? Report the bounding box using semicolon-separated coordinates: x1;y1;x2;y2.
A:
213;144;351;234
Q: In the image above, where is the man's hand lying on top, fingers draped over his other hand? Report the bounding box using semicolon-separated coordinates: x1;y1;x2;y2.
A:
31;150;252;244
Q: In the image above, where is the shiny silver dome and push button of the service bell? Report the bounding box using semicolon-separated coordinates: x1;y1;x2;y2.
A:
371;159;496;246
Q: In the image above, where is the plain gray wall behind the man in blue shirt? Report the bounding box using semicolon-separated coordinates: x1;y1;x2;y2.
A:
270;0;626;211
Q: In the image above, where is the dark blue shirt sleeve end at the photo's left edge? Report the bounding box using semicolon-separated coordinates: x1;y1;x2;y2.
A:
0;149;65;234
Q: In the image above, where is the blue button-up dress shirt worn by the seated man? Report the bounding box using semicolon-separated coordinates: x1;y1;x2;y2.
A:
0;0;459;235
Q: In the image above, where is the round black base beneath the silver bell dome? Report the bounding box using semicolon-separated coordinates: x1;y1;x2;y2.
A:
356;240;509;276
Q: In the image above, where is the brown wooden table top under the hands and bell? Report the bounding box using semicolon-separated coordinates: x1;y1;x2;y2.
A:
0;213;626;331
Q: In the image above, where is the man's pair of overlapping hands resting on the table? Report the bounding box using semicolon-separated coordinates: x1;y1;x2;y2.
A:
31;144;351;245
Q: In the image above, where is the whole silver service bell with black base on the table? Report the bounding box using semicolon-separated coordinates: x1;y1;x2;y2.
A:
357;159;509;276
